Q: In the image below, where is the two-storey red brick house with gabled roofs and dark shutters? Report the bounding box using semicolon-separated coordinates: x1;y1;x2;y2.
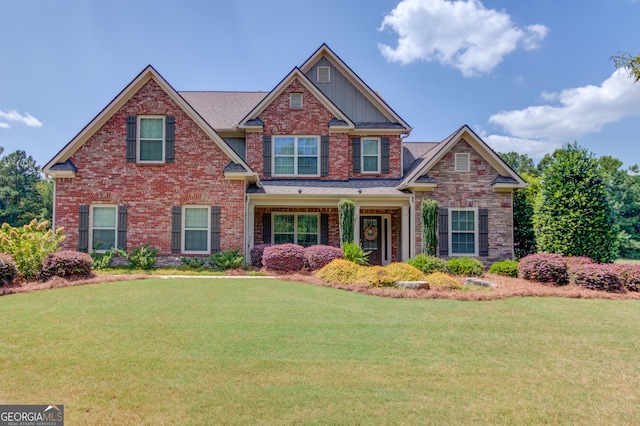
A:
43;45;525;264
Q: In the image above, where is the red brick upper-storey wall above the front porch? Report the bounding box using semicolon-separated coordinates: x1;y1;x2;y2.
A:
246;80;402;180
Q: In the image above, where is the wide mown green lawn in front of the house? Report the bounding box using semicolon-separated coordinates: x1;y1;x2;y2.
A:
0;278;640;425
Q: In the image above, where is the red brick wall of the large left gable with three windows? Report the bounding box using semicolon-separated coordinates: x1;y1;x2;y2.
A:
55;81;244;255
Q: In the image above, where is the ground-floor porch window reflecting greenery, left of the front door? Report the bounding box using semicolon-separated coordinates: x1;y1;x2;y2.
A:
272;213;320;247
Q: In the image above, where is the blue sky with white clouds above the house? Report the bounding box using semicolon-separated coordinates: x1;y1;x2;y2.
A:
0;0;640;166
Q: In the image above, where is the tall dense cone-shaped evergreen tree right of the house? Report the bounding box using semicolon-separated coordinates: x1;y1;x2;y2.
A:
533;143;618;262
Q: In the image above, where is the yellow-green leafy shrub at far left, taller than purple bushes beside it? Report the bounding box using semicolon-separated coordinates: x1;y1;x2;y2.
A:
0;219;65;279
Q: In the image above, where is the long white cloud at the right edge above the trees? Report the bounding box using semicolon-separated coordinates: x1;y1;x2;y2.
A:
483;71;640;157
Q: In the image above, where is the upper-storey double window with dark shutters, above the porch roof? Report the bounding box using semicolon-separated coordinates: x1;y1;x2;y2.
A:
273;136;319;176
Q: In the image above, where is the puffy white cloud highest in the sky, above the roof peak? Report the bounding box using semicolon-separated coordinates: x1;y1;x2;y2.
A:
378;0;549;76
